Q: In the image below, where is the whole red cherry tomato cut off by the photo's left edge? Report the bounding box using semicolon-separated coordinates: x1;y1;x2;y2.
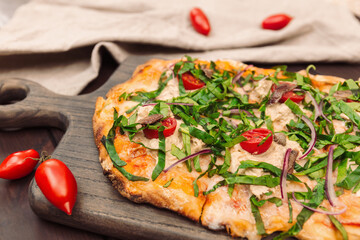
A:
0;149;40;180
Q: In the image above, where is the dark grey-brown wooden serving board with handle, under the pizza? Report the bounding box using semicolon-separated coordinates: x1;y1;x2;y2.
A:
0;57;231;240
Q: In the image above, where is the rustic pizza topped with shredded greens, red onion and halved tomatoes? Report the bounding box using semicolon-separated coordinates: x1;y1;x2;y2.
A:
93;56;360;240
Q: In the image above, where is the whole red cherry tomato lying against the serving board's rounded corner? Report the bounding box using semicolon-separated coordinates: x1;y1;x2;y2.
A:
35;159;77;215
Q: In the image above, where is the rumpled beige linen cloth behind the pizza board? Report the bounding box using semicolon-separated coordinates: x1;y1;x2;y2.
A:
0;0;360;95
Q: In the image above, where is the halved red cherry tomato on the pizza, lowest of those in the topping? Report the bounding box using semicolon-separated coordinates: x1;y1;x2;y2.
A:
240;128;273;155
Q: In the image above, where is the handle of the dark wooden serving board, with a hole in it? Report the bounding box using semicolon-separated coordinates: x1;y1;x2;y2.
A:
0;78;68;130
